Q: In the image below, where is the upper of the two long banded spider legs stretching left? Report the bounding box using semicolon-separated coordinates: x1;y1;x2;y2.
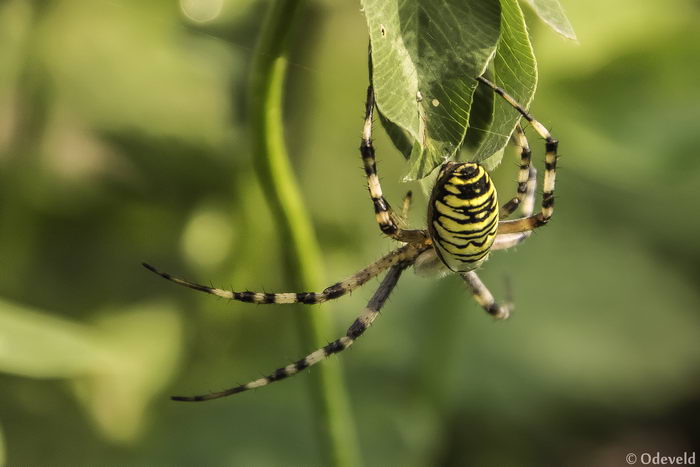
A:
143;244;426;305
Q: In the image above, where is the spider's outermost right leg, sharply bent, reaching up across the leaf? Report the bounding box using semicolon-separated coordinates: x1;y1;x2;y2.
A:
476;76;559;238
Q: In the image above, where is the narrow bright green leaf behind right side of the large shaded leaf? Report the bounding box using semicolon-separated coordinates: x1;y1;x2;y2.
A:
468;0;537;170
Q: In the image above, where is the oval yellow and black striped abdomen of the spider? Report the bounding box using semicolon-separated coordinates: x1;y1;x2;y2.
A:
428;162;498;272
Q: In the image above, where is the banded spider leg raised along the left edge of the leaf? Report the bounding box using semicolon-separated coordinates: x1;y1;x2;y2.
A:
360;85;428;242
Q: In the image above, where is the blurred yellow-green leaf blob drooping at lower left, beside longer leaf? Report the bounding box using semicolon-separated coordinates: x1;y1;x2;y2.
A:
72;302;182;443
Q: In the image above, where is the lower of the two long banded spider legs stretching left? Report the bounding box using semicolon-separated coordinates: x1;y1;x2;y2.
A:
172;257;415;402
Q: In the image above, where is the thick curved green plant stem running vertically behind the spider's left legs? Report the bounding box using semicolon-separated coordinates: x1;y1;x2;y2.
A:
248;0;360;466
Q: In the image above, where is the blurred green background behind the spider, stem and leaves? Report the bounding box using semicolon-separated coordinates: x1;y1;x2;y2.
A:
0;0;700;466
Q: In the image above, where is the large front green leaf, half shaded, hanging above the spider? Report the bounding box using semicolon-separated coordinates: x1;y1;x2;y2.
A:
362;0;501;180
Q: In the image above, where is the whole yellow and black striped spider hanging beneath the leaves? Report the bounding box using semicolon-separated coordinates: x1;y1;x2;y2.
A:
143;77;557;402
